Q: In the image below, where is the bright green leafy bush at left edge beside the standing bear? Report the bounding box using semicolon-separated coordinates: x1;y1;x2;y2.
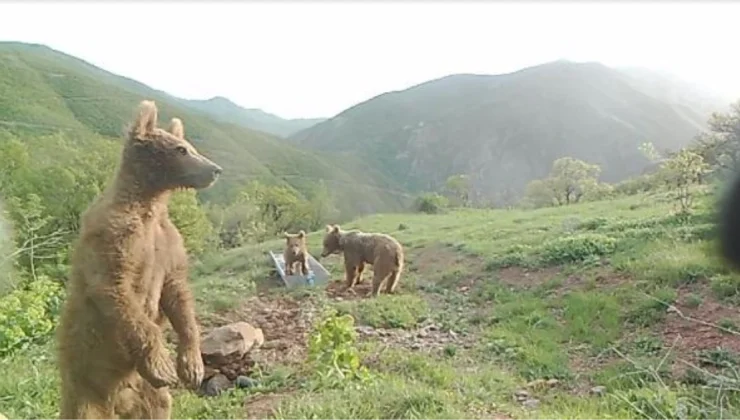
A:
0;278;64;357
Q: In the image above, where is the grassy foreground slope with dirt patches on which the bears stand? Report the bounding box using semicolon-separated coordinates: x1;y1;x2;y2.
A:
5;188;740;420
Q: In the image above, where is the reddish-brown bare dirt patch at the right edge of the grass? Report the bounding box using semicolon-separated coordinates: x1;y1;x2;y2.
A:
659;288;740;370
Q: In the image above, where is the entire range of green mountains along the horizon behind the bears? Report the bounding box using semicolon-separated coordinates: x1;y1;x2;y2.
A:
0;42;726;209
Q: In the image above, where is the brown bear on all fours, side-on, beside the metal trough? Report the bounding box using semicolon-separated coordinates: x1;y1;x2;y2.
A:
321;225;403;297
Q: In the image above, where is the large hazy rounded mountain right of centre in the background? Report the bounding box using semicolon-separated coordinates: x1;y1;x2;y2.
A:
290;61;727;203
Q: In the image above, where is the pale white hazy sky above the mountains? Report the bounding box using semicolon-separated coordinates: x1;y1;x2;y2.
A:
0;1;740;118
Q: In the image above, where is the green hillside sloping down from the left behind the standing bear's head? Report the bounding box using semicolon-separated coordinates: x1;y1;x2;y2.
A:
0;43;407;215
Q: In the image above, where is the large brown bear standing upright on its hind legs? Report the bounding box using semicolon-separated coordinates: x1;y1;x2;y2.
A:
57;101;221;420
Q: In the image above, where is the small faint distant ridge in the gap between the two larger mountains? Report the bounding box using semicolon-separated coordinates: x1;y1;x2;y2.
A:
178;96;326;137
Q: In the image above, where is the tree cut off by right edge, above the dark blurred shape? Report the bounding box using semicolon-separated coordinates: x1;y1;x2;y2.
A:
693;101;740;171
